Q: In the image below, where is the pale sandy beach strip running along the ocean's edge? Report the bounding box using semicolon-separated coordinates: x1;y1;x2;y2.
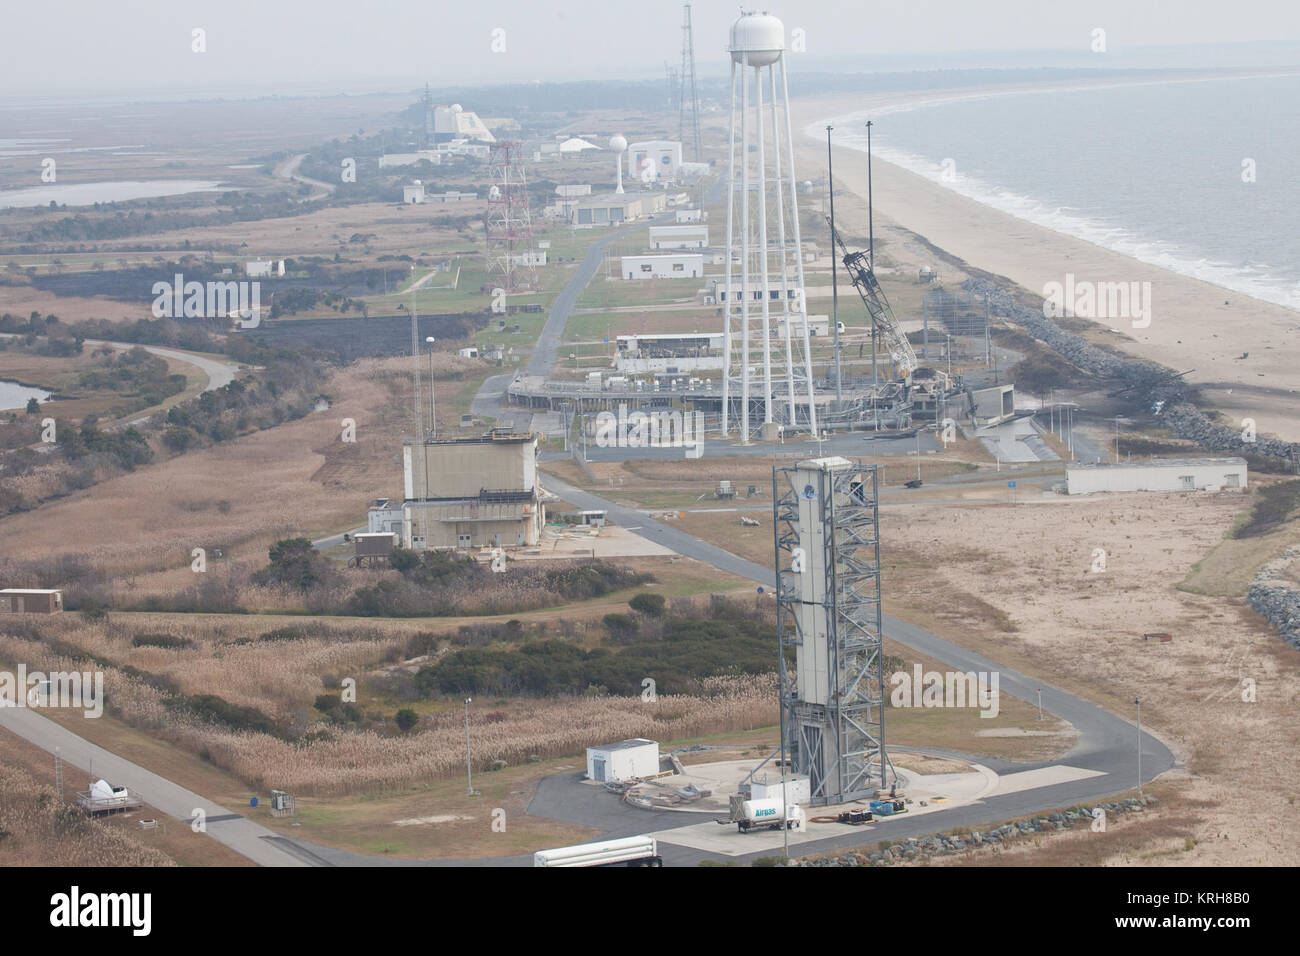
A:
769;87;1300;441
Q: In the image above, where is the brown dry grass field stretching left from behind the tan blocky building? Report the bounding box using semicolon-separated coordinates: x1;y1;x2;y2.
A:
3;356;483;582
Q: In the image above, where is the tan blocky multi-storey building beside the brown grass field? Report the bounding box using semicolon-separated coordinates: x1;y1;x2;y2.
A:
402;428;549;550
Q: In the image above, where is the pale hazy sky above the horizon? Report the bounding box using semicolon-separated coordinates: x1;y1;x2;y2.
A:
0;0;1300;95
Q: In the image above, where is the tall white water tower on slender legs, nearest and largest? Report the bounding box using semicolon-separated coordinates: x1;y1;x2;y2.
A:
723;13;816;442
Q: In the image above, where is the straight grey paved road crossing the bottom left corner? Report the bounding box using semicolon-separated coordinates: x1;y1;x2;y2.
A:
0;708;309;866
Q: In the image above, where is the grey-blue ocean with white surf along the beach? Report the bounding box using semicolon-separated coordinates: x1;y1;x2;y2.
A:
807;73;1300;310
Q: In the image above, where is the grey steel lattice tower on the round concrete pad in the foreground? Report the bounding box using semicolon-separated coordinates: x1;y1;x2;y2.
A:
772;458;897;805
